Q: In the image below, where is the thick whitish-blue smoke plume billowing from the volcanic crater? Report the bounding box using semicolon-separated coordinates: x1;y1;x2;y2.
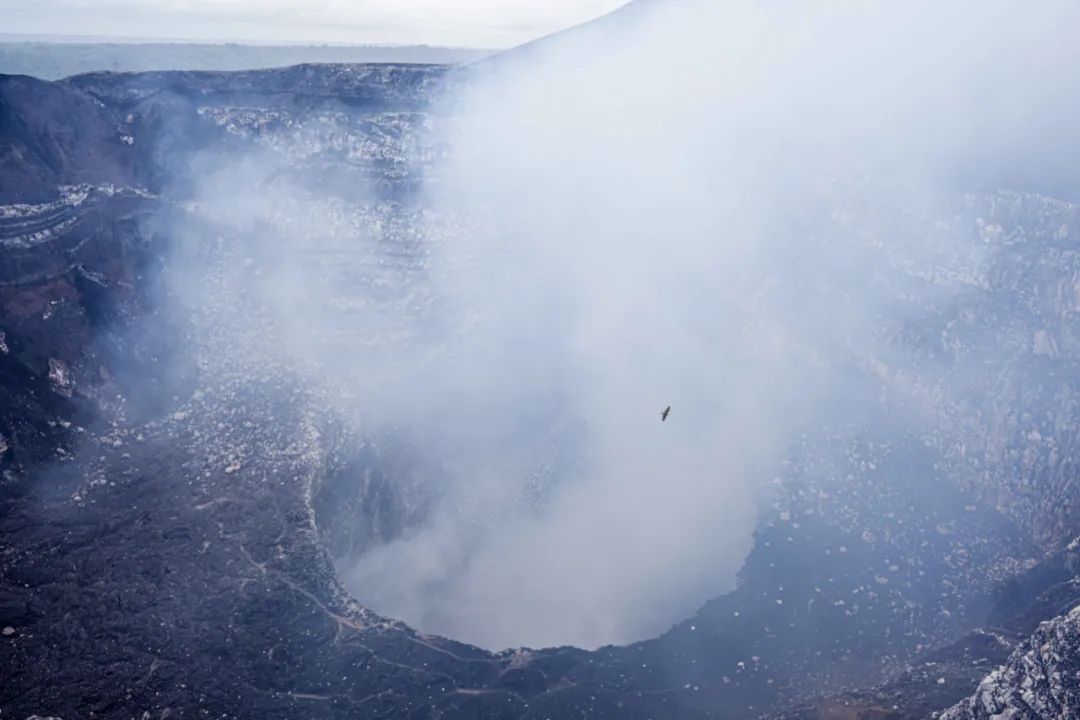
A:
170;0;1080;648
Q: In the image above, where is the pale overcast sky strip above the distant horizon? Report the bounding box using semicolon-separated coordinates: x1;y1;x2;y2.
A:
0;0;625;47
